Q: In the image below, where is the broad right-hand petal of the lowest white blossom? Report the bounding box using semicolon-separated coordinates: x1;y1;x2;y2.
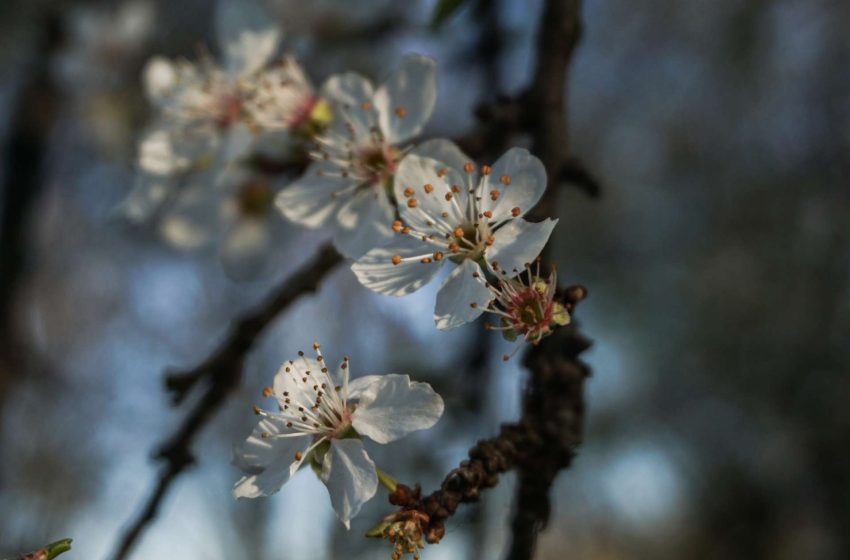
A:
349;373;444;443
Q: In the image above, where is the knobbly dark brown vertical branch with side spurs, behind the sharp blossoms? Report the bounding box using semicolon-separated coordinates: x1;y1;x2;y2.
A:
380;0;588;560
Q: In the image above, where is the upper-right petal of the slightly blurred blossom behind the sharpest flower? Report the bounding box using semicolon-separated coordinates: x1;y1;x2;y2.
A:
374;55;437;144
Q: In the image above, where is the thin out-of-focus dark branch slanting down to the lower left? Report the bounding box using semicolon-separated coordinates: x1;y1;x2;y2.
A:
112;245;342;560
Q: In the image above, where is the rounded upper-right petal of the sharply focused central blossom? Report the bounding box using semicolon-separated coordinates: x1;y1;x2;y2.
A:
481;148;546;221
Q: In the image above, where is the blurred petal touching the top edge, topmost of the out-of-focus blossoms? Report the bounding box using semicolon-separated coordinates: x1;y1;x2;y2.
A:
215;0;281;78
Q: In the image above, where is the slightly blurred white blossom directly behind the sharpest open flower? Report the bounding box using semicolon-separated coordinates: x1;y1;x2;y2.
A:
277;52;437;258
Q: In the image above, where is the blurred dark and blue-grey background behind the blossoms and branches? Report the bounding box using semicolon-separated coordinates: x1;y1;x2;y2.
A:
0;0;850;560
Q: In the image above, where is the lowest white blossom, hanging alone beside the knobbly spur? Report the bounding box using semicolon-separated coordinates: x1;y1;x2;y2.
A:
233;344;444;527
